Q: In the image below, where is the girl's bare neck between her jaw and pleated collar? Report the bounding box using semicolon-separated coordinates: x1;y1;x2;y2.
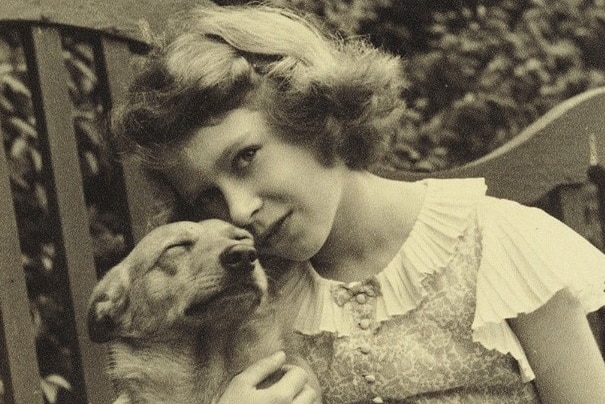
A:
311;171;426;282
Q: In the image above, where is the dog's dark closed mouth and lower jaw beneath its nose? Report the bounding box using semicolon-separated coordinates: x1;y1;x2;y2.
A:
185;283;263;318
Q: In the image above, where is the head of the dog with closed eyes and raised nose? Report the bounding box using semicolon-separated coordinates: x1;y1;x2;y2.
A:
88;220;267;342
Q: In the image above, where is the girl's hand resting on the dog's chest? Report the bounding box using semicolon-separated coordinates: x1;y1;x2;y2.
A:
217;351;320;404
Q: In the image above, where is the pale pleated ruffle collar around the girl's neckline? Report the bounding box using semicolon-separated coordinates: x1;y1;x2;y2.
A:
281;178;486;336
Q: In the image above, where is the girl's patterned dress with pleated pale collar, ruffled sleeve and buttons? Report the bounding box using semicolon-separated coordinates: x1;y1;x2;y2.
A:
281;179;605;403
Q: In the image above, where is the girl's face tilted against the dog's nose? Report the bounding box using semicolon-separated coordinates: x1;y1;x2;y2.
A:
165;108;349;261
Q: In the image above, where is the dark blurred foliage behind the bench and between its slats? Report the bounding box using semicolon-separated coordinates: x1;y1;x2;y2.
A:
0;0;605;403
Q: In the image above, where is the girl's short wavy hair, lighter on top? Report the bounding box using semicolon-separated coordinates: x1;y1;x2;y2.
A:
114;5;405;169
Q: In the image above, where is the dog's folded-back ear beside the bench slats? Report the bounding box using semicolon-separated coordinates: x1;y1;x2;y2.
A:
88;263;130;343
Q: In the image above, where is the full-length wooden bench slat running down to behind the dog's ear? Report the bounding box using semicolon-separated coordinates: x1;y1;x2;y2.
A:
32;27;112;403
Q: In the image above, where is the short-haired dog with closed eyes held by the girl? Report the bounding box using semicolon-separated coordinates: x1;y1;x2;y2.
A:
88;220;318;404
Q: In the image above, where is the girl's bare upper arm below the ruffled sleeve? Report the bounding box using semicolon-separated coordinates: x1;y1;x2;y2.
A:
509;290;605;404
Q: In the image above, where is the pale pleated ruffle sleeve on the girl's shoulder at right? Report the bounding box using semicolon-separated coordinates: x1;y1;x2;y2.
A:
472;197;605;381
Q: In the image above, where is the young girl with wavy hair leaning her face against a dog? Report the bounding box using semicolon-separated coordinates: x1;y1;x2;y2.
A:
116;6;605;403
